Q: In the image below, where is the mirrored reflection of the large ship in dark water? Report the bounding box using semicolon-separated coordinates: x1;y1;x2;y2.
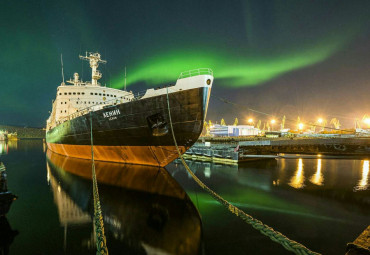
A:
47;150;202;254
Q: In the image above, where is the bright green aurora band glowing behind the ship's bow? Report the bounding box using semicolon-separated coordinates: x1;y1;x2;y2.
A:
111;34;352;88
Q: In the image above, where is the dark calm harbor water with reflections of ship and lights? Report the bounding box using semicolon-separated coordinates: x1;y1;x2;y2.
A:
0;140;370;254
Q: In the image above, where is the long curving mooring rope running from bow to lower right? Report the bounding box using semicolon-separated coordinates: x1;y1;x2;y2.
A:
167;88;320;255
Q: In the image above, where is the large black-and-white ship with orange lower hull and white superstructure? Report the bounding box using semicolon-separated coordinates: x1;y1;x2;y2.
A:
46;53;213;167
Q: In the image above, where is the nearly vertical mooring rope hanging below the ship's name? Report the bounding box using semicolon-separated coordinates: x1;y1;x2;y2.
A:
90;112;108;254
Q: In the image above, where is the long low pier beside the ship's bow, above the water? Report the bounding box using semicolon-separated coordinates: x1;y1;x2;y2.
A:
184;138;370;164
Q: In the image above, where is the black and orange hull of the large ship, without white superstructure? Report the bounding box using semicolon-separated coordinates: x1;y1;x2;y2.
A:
46;87;210;166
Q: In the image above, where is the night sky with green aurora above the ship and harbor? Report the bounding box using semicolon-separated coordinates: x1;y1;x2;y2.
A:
0;0;370;127
